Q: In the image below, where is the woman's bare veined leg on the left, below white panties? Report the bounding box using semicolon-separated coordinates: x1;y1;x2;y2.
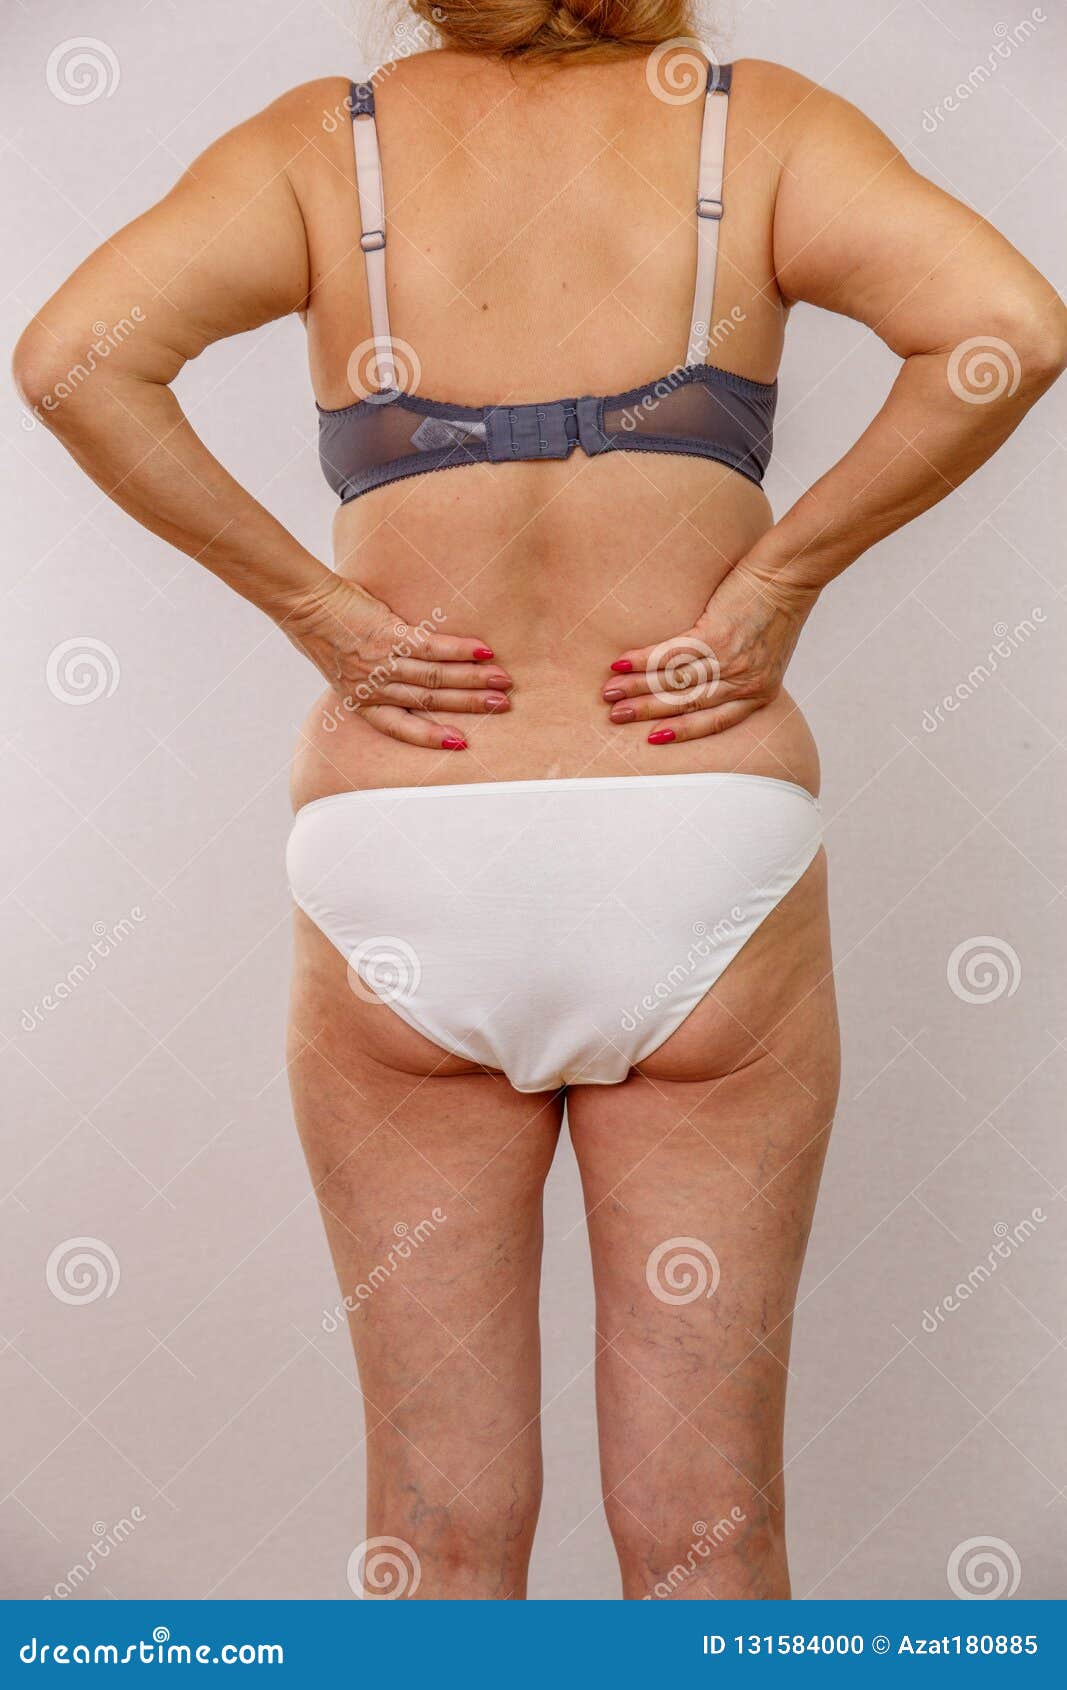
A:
289;916;561;1599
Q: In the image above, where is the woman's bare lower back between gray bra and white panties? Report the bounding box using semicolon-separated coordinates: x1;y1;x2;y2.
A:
293;453;818;810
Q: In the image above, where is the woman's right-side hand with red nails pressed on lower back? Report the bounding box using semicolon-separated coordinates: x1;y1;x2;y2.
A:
604;561;818;745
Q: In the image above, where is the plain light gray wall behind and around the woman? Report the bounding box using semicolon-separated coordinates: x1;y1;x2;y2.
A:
0;0;1067;1597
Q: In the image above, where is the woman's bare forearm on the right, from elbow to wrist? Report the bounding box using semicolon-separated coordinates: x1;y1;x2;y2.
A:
742;327;1064;592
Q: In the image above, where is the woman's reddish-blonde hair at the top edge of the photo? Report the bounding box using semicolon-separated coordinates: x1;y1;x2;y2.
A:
409;0;693;63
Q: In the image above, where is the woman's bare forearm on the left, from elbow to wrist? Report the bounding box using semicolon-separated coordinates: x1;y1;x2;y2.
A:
29;375;335;620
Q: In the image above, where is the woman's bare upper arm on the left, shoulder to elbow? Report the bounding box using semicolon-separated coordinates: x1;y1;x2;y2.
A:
15;83;335;402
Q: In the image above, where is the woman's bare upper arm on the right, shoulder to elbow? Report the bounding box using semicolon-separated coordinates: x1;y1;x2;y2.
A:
774;68;1065;363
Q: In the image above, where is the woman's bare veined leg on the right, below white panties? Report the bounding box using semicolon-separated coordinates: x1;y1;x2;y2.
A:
568;853;837;1599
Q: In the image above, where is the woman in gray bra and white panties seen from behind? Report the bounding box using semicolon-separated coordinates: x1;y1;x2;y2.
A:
17;0;1067;1599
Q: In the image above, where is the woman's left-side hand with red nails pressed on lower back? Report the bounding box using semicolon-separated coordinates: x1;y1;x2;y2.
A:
277;575;514;750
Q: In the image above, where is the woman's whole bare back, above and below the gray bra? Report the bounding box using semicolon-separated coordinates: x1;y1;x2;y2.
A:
293;52;817;804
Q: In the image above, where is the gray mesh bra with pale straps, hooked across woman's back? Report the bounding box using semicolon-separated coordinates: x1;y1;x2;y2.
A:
318;64;778;504
